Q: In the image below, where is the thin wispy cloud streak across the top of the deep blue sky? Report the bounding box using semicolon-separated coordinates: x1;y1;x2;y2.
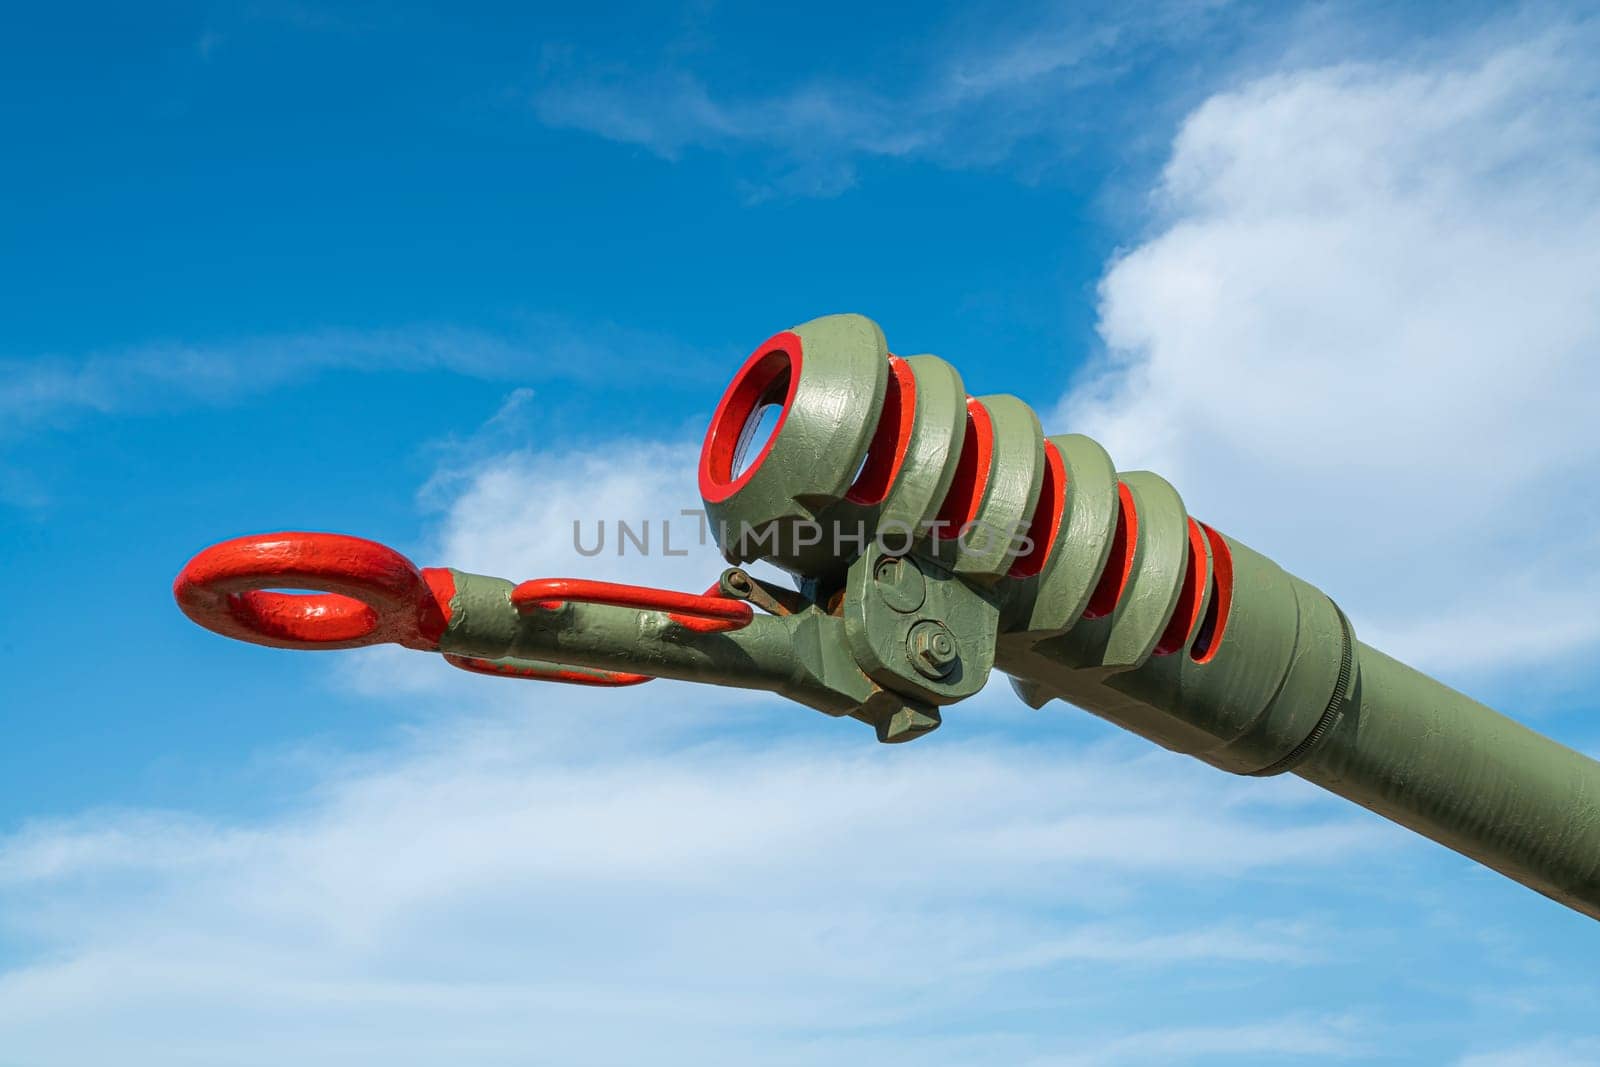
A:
533;0;1224;197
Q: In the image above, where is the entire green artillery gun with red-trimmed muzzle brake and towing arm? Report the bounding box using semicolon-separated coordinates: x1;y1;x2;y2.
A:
174;307;1600;918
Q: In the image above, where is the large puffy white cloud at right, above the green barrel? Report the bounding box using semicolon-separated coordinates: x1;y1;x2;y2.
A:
1059;27;1600;670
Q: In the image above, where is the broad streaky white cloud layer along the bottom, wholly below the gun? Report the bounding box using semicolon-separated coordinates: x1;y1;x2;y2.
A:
0;710;1386;1064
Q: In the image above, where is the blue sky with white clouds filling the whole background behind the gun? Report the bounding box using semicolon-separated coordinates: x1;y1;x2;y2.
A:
0;3;1600;1067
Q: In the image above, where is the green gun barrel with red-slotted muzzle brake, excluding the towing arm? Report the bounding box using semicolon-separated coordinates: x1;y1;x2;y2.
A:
701;315;1600;918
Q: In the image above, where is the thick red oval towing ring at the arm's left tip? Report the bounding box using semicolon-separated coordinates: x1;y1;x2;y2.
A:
173;533;453;651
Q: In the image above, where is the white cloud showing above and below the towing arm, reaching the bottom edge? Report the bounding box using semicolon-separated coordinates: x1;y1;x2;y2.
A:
0;385;1587;1067
